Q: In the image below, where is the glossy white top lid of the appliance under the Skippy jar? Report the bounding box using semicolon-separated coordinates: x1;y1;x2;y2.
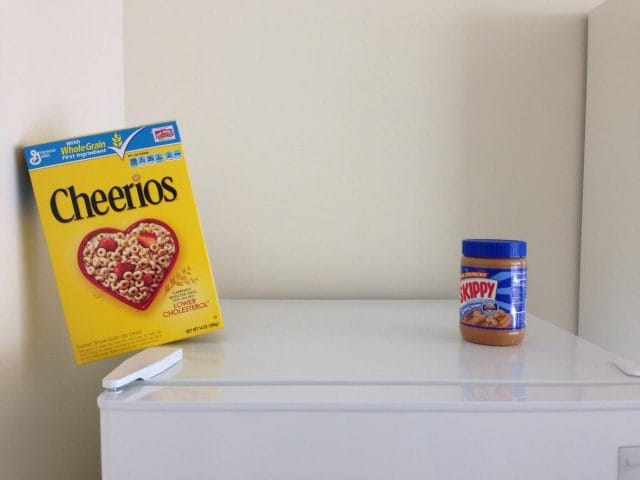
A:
101;300;640;407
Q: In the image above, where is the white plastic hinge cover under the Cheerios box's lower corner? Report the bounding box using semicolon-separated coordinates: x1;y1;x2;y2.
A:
102;346;182;390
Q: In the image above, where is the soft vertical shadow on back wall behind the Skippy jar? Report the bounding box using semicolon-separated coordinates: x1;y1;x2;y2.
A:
460;15;586;328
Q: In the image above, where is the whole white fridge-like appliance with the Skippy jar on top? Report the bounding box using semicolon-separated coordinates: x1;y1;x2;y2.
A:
98;300;640;480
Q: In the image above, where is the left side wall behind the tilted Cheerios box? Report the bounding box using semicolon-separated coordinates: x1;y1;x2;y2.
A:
0;0;124;480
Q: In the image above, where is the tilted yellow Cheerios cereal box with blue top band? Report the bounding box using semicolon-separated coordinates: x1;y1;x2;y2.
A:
24;122;223;364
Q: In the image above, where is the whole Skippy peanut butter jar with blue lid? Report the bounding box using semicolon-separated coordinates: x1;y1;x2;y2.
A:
460;239;527;345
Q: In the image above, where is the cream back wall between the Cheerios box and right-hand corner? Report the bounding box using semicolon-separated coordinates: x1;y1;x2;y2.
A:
124;0;599;330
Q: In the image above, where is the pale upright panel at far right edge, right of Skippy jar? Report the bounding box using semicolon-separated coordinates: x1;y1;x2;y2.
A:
580;0;640;362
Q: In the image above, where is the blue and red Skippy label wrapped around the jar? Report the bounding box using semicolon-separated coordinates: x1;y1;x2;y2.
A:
460;267;527;329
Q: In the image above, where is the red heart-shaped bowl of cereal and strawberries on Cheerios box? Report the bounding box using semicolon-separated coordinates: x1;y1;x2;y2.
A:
78;218;178;310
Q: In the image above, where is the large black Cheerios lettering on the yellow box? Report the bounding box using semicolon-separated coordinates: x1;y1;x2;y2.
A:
49;176;178;223
